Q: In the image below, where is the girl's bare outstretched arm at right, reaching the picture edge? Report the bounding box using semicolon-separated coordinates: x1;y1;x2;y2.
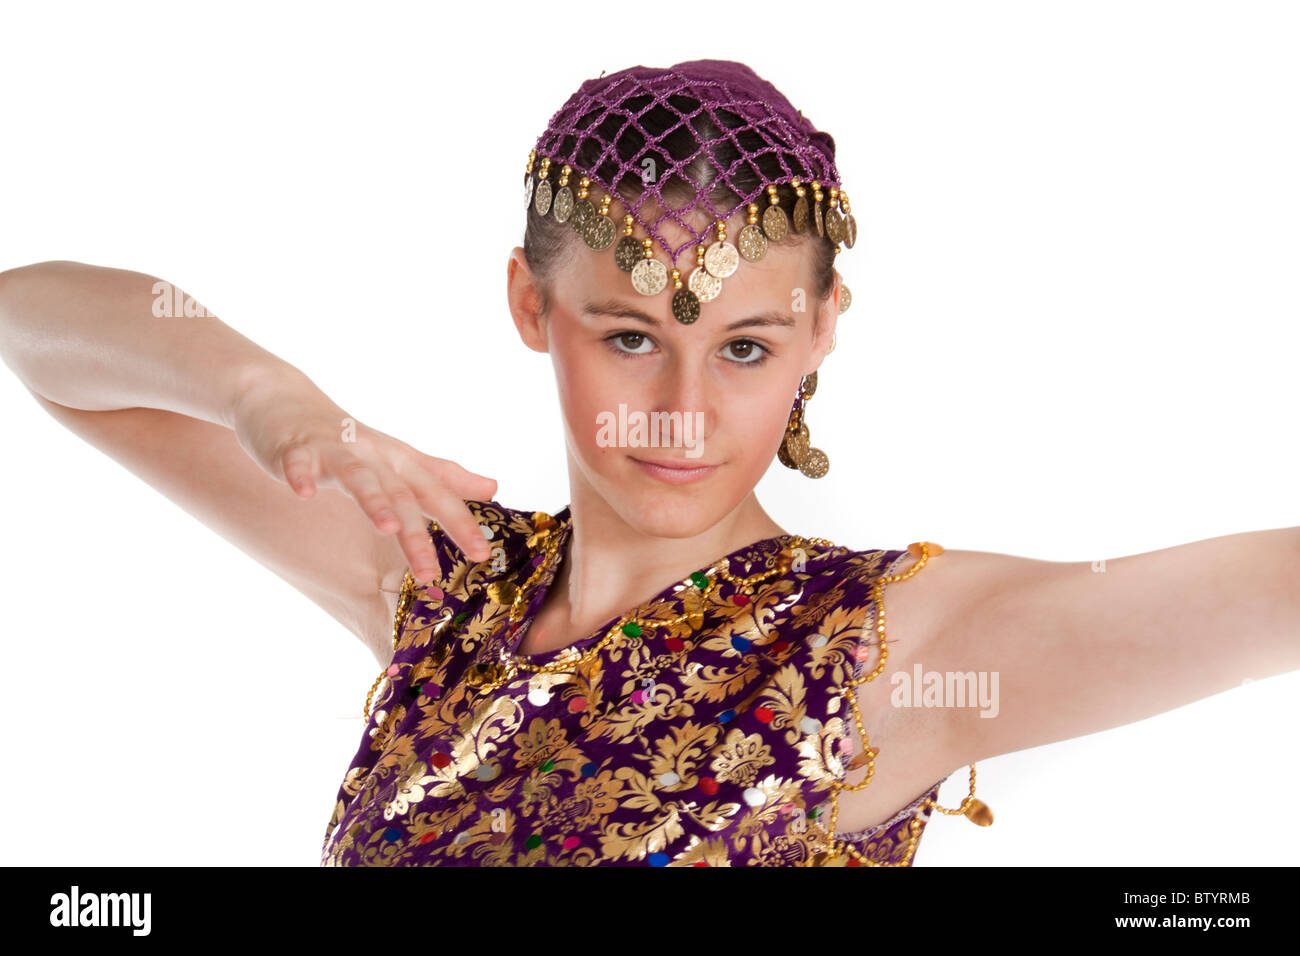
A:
891;528;1300;763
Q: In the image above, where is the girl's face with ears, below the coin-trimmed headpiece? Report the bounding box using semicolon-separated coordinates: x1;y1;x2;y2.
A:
510;213;840;537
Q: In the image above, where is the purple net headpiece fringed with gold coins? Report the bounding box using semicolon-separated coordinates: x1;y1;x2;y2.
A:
524;60;857;324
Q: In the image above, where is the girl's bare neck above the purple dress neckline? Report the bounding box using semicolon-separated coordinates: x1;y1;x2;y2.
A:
547;459;788;633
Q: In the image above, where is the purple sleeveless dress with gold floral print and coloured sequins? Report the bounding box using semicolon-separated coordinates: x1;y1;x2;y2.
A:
321;501;948;866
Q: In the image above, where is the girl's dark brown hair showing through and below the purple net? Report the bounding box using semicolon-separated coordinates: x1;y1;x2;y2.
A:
524;92;836;332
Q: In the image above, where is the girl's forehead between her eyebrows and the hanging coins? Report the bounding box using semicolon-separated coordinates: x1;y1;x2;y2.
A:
556;203;813;325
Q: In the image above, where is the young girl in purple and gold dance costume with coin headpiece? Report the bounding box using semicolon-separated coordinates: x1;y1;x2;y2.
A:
0;60;1300;866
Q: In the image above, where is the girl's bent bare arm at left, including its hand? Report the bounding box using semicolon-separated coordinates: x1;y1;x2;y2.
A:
0;261;495;662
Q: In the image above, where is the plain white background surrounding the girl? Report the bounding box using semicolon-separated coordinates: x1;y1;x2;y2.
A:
0;0;1300;868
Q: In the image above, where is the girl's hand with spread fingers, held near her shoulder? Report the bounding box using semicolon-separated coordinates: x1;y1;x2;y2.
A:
234;369;497;584
